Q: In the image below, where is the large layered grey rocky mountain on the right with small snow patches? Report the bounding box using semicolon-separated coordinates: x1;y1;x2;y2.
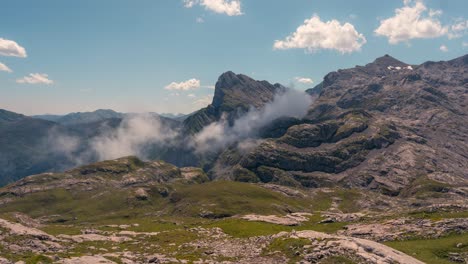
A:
213;55;468;195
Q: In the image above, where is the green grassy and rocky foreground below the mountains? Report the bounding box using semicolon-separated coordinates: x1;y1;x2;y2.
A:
0;157;468;263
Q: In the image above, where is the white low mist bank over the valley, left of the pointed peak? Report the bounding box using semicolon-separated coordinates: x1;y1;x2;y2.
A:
46;113;178;166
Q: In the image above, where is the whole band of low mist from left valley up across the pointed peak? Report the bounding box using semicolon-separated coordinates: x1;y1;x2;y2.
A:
47;89;312;167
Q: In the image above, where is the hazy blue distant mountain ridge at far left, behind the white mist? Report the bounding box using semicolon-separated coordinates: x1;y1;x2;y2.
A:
0;109;180;186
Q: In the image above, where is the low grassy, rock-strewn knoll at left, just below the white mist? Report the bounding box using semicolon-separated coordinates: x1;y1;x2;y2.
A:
0;156;182;197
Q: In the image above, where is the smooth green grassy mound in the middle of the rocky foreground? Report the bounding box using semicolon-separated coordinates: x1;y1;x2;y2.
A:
166;181;310;218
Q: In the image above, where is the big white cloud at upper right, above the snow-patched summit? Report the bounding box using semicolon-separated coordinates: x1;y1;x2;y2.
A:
374;0;448;44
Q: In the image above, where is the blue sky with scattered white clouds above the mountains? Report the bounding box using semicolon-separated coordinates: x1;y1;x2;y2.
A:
0;0;468;114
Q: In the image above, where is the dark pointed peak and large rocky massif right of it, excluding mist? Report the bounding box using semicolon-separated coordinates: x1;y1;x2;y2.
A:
0;55;468;199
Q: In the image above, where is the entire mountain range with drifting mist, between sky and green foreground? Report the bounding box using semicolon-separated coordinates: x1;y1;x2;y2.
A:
0;55;468;192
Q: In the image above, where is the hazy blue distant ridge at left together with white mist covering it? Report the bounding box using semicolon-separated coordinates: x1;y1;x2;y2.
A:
0;110;180;185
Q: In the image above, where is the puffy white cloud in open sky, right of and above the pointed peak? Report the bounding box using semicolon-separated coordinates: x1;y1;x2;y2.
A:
273;15;366;54
